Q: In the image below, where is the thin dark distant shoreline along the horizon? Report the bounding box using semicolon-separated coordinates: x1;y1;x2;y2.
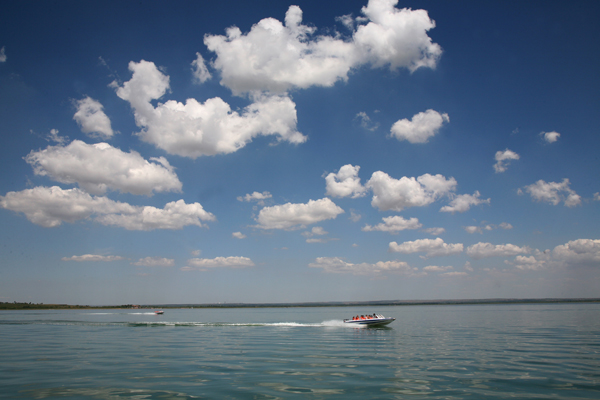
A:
0;298;600;310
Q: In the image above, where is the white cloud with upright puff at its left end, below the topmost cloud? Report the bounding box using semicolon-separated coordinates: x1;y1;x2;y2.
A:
117;60;306;159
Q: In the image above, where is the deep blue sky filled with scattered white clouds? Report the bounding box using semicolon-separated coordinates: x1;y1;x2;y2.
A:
0;0;600;305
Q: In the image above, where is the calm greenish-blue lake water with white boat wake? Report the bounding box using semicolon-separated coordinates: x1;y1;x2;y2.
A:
0;304;600;400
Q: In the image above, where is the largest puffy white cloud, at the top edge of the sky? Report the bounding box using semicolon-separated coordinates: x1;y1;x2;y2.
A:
204;0;442;94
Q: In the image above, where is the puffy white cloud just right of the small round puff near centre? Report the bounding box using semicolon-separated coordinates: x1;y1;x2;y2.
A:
366;171;457;211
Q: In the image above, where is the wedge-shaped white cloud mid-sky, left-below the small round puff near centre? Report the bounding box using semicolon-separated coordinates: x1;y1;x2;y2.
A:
256;198;344;229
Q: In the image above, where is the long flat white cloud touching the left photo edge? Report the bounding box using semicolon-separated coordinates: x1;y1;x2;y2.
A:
0;186;215;231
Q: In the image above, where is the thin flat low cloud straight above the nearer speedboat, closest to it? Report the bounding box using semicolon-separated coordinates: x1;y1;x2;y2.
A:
308;257;417;275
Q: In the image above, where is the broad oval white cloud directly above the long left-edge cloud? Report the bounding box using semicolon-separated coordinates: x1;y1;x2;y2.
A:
25;140;182;196
